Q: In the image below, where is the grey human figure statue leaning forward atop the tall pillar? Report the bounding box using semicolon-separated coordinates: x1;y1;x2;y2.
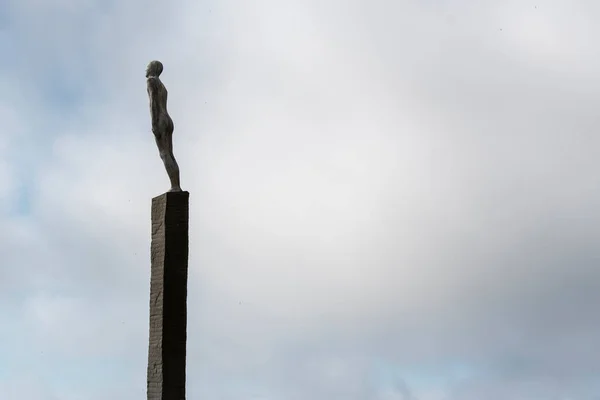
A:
146;61;181;192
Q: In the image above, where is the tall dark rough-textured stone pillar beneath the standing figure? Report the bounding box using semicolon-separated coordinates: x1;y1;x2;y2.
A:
147;192;190;400
